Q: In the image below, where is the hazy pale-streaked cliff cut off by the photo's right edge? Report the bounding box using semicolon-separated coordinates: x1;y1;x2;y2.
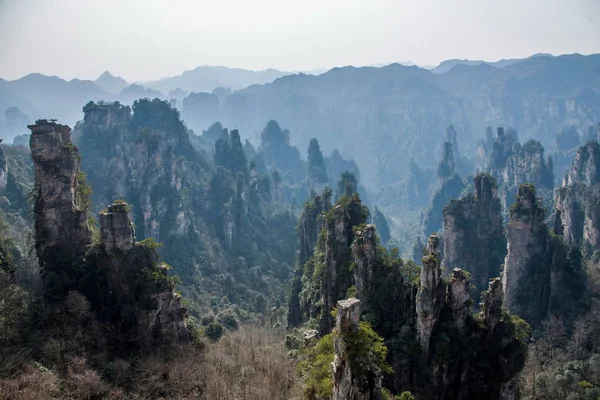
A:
554;141;600;254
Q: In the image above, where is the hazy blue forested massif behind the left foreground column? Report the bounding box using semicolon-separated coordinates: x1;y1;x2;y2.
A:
76;99;296;319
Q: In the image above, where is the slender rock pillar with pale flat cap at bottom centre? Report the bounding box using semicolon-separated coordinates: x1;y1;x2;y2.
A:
331;298;382;400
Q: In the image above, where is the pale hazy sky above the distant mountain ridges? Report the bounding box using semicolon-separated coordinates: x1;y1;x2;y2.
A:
0;0;600;81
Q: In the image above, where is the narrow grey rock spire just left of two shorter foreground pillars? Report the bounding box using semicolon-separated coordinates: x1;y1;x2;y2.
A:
416;234;446;360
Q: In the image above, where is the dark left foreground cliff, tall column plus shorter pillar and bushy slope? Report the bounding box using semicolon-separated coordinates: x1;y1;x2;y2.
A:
29;120;187;351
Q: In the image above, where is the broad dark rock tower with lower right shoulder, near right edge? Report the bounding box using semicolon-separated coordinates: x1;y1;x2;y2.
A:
502;185;585;327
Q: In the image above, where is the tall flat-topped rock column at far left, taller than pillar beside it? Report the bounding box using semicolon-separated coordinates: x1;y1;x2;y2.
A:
28;120;91;298
